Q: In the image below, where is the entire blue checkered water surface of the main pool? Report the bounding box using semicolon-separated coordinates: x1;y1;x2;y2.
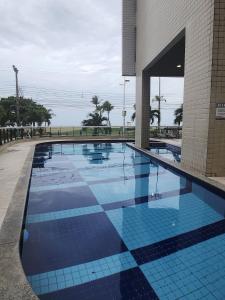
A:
21;143;225;300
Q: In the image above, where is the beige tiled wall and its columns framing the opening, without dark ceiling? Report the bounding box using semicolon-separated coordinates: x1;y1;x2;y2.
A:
136;0;225;176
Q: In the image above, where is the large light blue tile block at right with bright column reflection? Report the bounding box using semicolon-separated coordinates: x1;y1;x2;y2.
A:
106;193;223;250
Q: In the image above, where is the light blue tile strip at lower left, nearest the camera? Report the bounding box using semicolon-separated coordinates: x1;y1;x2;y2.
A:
28;252;137;294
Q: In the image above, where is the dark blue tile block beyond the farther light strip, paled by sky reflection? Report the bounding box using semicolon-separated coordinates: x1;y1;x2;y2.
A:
28;186;98;214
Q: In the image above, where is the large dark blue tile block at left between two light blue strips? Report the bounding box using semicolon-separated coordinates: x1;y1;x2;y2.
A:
22;213;127;275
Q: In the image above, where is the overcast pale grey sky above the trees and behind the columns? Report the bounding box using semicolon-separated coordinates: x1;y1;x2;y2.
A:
0;0;183;126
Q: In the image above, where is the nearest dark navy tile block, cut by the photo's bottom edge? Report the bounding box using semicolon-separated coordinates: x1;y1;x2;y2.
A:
40;268;158;300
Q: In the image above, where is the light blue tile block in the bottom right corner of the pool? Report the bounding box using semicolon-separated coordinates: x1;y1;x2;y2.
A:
140;234;225;299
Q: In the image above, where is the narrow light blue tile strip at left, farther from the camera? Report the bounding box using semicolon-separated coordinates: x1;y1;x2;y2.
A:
26;205;103;224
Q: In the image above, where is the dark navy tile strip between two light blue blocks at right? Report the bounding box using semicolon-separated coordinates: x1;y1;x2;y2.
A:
131;220;225;265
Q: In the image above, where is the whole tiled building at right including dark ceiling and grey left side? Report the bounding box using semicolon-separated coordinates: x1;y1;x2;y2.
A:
122;0;225;176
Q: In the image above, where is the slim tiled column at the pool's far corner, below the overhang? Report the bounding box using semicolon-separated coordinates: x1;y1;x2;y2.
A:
135;72;150;148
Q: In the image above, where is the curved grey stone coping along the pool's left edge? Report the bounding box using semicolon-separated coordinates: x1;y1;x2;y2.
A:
0;143;39;300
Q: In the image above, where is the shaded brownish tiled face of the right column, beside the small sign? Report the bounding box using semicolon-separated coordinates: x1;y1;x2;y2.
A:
206;0;225;177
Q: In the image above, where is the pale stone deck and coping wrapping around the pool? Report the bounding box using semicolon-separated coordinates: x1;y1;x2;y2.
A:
0;138;225;300
